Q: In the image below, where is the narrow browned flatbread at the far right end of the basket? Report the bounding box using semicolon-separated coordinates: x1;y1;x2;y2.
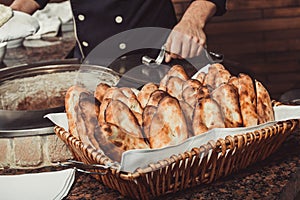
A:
255;80;275;124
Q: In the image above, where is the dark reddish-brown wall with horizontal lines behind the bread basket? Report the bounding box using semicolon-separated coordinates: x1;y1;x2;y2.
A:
173;0;300;99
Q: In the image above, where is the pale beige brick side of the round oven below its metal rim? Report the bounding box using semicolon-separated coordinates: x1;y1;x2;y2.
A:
0;133;73;169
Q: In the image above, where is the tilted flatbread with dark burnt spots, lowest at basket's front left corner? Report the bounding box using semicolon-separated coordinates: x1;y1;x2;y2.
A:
95;123;149;162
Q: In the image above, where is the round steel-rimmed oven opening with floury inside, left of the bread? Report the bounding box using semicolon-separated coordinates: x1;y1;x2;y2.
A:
0;61;119;137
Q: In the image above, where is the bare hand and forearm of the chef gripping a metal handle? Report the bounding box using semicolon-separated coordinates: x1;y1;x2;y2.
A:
165;0;225;62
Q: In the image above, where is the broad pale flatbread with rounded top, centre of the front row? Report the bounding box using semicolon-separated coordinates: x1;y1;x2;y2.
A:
149;96;188;148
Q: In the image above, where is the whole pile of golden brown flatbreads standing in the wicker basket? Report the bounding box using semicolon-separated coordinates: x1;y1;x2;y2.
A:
65;64;274;161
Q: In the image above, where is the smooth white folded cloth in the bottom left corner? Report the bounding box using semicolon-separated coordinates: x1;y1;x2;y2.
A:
0;169;75;200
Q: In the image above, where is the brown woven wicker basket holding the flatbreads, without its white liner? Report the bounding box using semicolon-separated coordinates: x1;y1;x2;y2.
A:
55;117;300;199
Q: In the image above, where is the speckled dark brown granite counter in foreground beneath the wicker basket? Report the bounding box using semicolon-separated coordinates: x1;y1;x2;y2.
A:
0;130;300;200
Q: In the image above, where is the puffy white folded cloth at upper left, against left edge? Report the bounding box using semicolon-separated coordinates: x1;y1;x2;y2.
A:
0;11;40;42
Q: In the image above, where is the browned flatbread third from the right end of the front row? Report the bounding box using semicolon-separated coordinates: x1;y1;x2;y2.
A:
211;84;243;128
